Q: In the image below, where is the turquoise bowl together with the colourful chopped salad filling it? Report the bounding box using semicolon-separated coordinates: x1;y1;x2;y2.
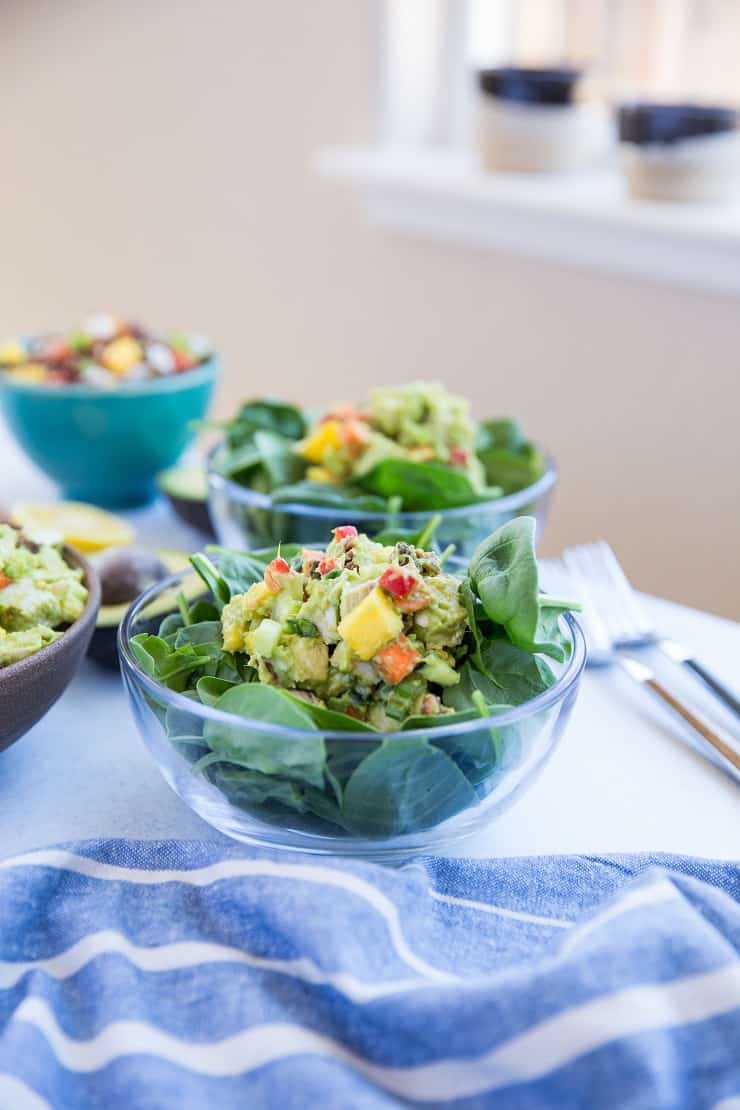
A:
0;314;220;506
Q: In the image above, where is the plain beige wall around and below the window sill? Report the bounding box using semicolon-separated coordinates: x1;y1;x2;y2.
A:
0;0;740;617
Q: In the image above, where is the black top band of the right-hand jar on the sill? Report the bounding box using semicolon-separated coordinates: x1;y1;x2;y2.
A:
617;101;740;147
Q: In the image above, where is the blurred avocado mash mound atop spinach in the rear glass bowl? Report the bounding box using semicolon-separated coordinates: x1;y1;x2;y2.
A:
295;382;486;491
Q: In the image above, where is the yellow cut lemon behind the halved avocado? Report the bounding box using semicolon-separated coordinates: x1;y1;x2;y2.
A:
10;501;135;552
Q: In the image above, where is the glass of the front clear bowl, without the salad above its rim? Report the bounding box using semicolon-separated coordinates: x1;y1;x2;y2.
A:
119;572;586;862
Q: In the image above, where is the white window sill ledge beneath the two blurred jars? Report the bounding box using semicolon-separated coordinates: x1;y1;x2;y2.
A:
316;148;740;294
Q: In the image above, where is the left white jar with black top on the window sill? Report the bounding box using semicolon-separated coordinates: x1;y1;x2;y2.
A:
478;67;612;173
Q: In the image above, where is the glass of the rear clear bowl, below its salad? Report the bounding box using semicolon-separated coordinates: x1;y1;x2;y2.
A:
209;445;558;558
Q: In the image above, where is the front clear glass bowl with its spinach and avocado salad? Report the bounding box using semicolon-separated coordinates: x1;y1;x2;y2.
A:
119;518;586;861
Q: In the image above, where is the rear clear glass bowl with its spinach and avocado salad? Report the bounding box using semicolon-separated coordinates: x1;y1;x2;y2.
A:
209;382;558;557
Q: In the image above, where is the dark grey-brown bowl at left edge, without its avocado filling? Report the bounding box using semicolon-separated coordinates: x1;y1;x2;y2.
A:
0;545;100;751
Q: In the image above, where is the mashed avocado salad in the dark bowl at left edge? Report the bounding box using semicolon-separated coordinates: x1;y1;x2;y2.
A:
0;524;88;668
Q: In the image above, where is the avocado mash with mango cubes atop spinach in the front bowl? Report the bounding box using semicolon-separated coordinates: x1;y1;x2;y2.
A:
221;525;467;730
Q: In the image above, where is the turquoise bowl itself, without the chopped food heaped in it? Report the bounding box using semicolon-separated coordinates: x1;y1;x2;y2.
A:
0;357;221;508
